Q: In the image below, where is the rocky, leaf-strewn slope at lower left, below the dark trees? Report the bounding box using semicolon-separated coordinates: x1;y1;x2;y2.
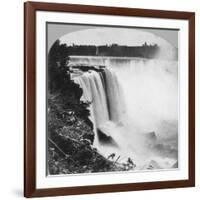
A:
48;94;127;175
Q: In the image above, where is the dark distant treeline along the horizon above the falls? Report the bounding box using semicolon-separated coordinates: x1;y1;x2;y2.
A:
67;43;159;58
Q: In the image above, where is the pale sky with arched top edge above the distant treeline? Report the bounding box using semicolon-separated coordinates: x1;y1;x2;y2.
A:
47;23;178;50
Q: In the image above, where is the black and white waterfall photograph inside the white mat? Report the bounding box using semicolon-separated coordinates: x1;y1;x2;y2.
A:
46;22;180;175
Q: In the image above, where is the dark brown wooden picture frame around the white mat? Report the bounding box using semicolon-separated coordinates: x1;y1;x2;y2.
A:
24;2;195;197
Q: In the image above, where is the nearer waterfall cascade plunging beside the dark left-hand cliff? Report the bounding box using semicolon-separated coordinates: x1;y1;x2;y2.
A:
73;68;125;145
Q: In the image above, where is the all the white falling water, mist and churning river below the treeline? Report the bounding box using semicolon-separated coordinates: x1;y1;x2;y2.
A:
70;56;178;169
